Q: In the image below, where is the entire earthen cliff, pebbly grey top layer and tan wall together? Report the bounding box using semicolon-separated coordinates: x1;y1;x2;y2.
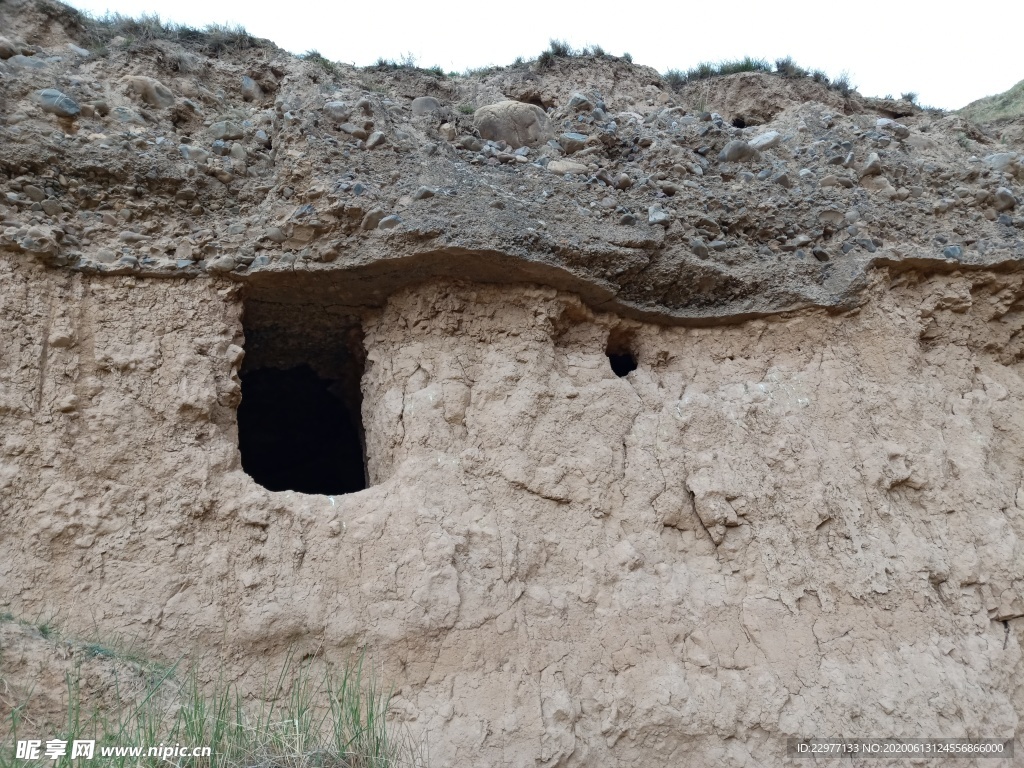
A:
0;0;1024;768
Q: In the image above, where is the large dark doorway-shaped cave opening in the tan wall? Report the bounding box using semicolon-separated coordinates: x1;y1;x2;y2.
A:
238;301;367;496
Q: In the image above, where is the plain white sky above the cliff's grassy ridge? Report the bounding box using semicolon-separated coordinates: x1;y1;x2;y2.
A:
71;0;1024;110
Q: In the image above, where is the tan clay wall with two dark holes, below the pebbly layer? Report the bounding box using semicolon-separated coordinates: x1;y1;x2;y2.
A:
0;250;1024;766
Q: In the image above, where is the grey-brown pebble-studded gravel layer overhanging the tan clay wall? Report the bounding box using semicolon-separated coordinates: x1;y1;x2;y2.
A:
0;2;1024;322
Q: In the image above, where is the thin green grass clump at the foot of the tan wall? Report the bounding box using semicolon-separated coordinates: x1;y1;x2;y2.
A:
0;615;427;768
